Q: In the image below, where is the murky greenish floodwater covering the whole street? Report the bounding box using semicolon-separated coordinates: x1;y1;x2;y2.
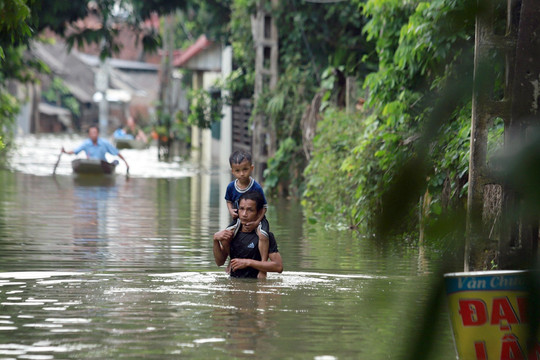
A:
0;136;455;360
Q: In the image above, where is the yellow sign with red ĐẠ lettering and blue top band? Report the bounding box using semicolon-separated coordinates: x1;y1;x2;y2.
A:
444;271;540;360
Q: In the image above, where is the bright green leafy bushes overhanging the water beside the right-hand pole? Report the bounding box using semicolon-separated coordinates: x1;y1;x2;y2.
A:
303;0;474;236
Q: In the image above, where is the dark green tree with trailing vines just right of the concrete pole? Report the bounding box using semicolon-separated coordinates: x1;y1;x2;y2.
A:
256;1;373;194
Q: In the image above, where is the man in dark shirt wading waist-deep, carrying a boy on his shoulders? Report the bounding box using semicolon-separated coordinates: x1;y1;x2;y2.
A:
213;191;283;278
